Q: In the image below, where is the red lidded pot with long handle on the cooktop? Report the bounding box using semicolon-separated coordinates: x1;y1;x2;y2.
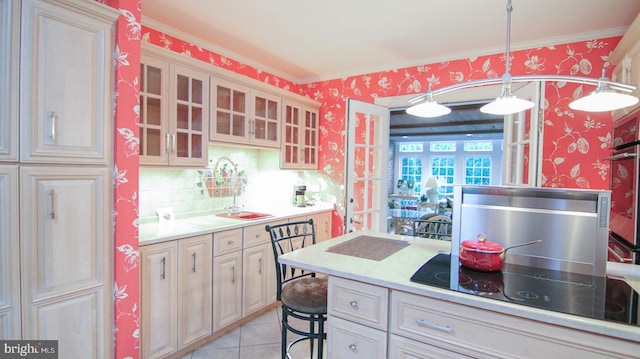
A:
460;233;542;272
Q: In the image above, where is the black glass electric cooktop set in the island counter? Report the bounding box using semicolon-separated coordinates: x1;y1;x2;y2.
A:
411;254;638;325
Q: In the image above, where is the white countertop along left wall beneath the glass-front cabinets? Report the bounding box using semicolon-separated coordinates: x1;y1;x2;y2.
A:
138;202;333;245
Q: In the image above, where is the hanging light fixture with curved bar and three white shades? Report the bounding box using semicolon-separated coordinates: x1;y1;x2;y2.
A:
407;0;639;117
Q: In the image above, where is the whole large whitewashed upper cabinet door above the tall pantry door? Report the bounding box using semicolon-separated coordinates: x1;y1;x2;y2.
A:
18;0;115;164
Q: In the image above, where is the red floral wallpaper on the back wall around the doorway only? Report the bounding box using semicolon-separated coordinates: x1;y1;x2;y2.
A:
307;37;620;194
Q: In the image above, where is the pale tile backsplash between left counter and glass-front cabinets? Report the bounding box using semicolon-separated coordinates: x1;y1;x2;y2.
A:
139;146;322;222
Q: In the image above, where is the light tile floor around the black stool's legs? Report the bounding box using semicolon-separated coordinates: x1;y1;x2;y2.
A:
182;307;326;359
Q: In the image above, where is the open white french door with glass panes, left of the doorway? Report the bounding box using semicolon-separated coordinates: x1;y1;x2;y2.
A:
345;99;389;233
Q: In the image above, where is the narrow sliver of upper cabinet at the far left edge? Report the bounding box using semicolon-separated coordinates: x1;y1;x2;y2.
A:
0;0;20;161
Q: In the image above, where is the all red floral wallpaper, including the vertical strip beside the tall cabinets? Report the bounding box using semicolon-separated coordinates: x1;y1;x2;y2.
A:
102;11;620;358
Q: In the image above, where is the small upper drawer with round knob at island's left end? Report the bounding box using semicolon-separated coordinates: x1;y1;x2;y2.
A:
327;277;388;330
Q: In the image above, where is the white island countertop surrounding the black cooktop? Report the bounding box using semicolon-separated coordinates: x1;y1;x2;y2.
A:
280;231;640;343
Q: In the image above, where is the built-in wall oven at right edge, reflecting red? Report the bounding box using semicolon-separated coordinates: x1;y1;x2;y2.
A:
607;111;640;264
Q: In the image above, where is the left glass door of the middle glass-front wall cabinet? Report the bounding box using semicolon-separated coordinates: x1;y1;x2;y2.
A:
209;78;250;143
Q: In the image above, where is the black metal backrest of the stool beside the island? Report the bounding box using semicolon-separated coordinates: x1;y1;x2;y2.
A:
265;219;316;300
